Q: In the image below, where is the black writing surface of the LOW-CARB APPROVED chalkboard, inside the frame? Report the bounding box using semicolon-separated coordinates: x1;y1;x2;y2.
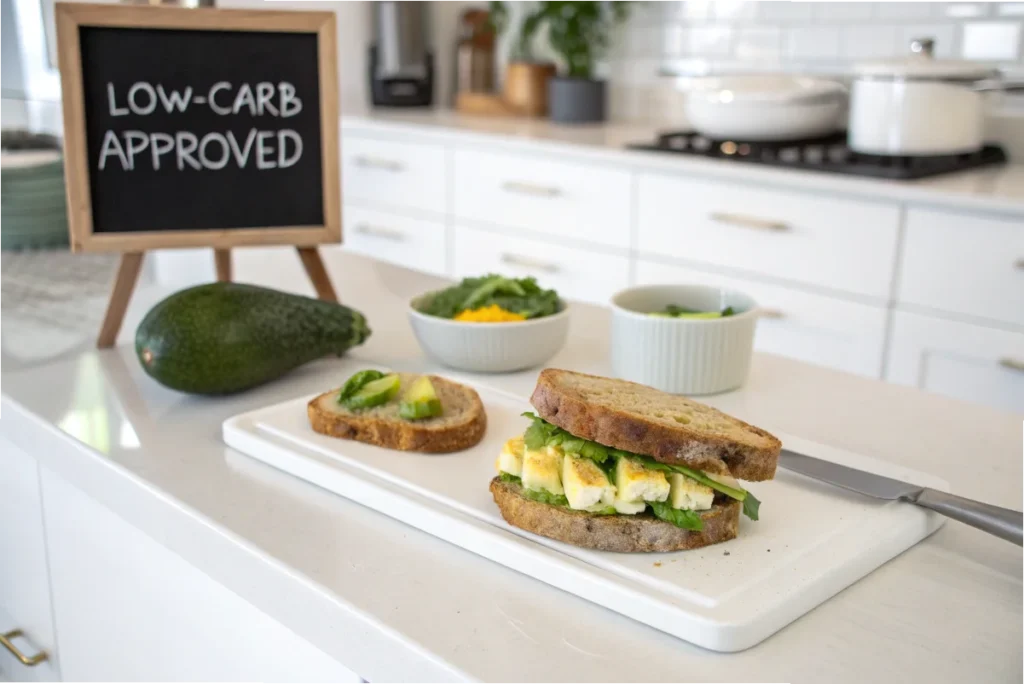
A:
80;27;324;232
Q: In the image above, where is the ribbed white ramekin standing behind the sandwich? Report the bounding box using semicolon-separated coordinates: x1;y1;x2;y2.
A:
611;285;758;394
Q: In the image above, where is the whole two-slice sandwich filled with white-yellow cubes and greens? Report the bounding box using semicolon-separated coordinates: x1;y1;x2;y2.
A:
490;369;782;552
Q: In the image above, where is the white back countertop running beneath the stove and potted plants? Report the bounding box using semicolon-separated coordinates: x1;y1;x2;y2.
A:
341;110;1024;214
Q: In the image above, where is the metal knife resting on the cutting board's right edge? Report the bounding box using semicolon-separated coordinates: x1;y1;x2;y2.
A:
778;448;1024;547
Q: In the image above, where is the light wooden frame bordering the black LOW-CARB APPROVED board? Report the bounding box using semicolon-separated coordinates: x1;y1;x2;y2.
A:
55;2;341;252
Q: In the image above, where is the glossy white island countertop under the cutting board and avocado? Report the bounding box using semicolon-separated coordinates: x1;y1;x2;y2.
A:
0;253;1024;684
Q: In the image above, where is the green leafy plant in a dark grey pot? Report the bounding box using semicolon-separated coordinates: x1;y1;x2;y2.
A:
496;0;638;123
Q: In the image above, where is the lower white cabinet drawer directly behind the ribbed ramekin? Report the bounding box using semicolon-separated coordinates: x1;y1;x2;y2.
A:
637;260;886;378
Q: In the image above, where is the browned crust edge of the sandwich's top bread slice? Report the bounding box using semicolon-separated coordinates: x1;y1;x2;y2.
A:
530;369;782;481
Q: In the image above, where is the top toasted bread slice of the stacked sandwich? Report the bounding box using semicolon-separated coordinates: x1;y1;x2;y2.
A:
530;369;782;480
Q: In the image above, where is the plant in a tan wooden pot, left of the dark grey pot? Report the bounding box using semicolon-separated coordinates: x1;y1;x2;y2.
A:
490;0;555;117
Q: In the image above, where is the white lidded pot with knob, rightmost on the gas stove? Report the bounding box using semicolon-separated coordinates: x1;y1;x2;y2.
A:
848;40;995;156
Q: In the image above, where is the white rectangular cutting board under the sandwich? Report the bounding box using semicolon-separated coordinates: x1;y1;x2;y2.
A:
223;378;949;651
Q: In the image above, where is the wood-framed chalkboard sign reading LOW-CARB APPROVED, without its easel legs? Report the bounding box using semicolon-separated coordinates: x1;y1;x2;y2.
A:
56;3;341;252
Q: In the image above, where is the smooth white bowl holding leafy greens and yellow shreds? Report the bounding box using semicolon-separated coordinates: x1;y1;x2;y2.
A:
409;295;569;373
